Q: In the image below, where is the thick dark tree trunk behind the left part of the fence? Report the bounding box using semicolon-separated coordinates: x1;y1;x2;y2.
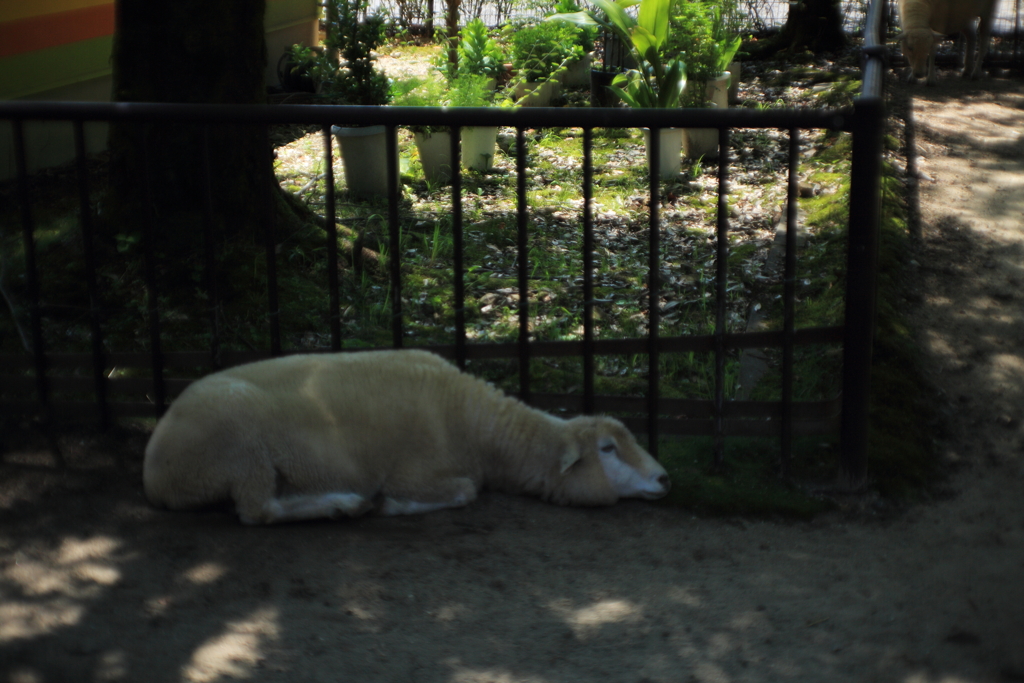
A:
109;0;272;254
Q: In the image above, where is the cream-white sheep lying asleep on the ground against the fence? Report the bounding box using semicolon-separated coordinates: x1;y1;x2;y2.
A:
142;350;669;524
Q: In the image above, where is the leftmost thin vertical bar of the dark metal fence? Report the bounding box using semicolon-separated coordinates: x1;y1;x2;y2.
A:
11;119;51;413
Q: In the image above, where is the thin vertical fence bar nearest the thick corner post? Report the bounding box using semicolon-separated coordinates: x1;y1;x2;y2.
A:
779;128;800;478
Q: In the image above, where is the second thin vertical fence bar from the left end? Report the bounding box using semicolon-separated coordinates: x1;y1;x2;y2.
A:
73;119;110;429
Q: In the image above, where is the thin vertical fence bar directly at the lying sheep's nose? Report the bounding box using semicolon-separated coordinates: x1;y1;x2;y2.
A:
647;126;662;458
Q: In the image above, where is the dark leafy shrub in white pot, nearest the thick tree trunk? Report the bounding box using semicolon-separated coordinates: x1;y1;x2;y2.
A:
315;0;398;199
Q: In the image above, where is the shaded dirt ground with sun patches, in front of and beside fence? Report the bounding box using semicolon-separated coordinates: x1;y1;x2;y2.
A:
0;80;1024;683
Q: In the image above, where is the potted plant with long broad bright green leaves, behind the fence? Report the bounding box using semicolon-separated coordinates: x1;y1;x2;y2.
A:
549;0;686;177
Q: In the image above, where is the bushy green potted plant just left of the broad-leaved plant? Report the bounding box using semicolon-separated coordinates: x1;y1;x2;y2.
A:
509;22;583;106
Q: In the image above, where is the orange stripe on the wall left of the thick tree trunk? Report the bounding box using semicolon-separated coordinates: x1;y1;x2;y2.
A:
0;4;114;58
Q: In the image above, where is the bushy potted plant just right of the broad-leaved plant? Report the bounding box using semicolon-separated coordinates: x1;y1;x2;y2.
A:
671;0;741;159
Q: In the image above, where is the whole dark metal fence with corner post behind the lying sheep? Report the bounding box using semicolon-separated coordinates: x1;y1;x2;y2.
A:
0;3;884;483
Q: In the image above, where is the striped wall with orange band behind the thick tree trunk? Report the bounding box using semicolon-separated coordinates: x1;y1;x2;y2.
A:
0;0;319;180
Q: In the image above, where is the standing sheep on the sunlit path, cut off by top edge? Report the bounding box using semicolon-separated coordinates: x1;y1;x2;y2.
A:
897;0;996;85
